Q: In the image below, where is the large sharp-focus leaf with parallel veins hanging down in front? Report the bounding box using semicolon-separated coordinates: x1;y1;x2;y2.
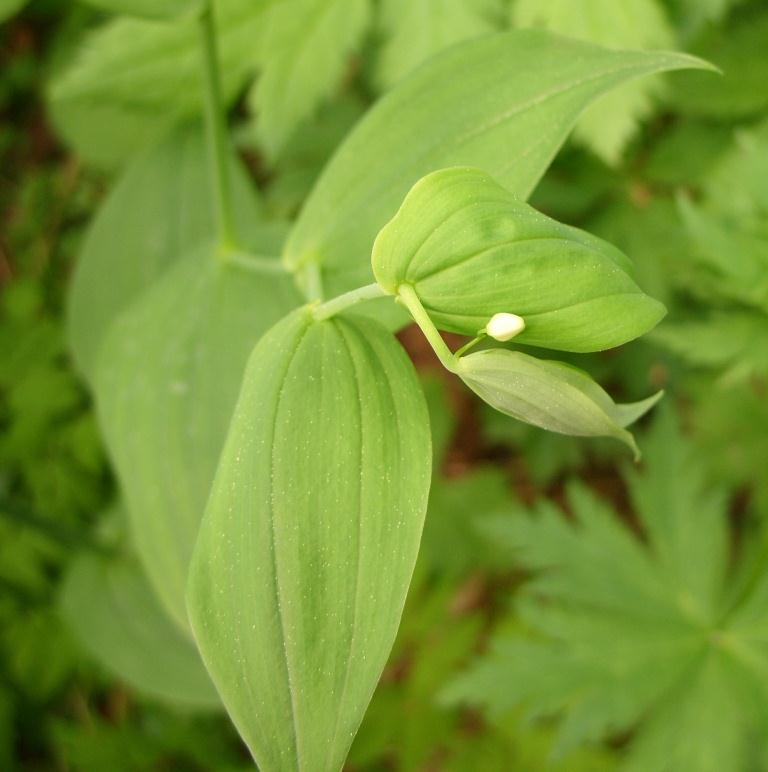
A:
189;309;431;772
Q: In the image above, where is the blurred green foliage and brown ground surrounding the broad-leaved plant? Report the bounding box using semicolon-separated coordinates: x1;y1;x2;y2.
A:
0;0;768;772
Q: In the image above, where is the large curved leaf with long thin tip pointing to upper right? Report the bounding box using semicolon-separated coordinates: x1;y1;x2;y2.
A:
284;30;706;294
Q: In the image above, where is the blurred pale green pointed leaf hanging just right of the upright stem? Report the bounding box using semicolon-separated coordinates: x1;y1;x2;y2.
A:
251;0;370;156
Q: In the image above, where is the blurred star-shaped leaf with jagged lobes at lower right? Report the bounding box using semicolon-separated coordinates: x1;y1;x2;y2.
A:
446;415;768;772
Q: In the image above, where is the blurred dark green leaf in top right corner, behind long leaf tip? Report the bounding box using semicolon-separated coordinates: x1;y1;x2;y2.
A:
669;3;768;120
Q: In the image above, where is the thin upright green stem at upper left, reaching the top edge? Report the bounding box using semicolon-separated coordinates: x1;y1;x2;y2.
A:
199;0;237;247
